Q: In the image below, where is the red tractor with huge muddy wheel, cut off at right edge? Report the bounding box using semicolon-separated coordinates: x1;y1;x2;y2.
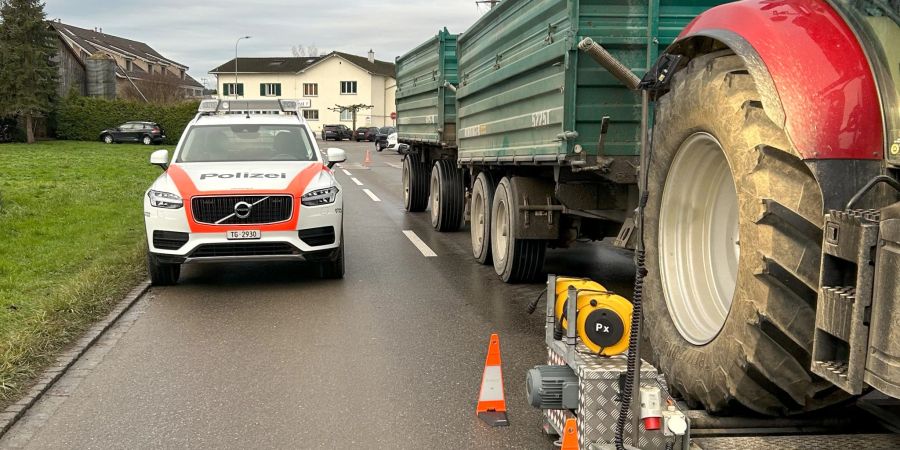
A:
643;0;900;415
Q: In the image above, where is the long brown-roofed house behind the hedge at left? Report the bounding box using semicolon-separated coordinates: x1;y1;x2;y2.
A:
50;20;204;98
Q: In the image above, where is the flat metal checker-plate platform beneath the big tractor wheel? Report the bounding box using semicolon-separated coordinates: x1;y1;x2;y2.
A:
691;434;900;450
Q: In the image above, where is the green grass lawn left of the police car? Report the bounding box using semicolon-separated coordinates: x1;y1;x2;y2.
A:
0;141;160;404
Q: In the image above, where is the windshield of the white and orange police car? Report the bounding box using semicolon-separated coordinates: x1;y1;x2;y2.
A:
177;124;316;162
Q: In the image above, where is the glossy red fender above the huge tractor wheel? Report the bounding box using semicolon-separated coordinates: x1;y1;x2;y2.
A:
676;0;884;160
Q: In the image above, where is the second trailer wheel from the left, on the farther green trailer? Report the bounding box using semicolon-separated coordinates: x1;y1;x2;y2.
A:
430;159;466;231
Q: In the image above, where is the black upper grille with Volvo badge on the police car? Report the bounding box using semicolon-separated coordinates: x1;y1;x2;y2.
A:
191;195;293;225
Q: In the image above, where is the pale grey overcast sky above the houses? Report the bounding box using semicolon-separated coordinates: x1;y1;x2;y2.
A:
45;0;485;85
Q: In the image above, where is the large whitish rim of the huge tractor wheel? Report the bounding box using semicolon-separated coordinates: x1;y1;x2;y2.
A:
659;133;740;345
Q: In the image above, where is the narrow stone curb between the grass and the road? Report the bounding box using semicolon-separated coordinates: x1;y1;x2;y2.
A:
0;280;150;438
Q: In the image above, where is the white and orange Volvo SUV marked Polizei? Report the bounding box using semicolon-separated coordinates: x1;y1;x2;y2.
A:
144;100;346;285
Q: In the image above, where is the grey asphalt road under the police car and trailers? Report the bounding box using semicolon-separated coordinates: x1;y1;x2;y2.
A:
0;142;633;449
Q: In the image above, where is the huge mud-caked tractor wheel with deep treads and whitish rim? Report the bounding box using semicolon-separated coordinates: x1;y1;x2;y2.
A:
643;50;846;415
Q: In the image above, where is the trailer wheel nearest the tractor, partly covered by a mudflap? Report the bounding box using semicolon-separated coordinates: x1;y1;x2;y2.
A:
491;177;547;283
